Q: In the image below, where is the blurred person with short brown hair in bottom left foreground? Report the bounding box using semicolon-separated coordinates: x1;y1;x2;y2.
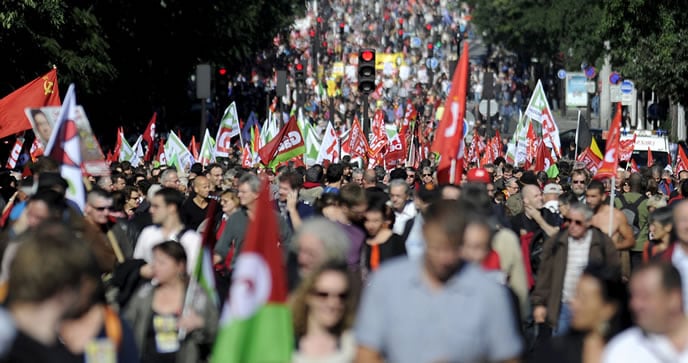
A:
0;222;93;363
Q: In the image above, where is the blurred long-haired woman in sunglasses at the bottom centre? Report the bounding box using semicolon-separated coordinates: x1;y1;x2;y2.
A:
291;262;358;363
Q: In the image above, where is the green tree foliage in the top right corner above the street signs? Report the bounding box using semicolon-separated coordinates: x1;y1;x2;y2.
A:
602;0;688;103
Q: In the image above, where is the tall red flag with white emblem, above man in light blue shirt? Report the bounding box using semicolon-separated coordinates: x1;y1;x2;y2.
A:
431;41;468;184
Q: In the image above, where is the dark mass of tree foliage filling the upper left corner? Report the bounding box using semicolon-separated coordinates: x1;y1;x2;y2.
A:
0;0;303;140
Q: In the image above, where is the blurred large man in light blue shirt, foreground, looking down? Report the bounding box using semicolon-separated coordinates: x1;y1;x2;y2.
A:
355;201;523;363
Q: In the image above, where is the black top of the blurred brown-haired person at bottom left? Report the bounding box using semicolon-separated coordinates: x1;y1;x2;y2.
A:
0;331;72;363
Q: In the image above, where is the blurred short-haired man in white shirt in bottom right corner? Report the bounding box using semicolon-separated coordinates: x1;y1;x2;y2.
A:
602;262;688;363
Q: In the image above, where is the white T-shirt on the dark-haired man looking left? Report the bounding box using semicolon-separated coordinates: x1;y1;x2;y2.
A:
134;226;201;275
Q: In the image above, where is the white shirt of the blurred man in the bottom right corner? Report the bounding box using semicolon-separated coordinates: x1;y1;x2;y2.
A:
602;327;688;363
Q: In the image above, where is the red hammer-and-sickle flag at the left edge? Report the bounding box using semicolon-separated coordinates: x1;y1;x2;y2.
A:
0;68;61;138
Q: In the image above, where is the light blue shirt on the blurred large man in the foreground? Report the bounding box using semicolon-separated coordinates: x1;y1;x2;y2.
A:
355;259;523;363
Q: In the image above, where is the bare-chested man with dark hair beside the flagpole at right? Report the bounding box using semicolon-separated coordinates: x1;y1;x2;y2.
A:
585;180;635;251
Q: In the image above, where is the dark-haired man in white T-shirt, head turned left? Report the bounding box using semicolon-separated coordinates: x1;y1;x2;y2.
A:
134;188;201;276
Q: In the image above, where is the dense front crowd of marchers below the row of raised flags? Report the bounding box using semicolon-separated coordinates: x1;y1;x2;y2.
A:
0;152;688;362
